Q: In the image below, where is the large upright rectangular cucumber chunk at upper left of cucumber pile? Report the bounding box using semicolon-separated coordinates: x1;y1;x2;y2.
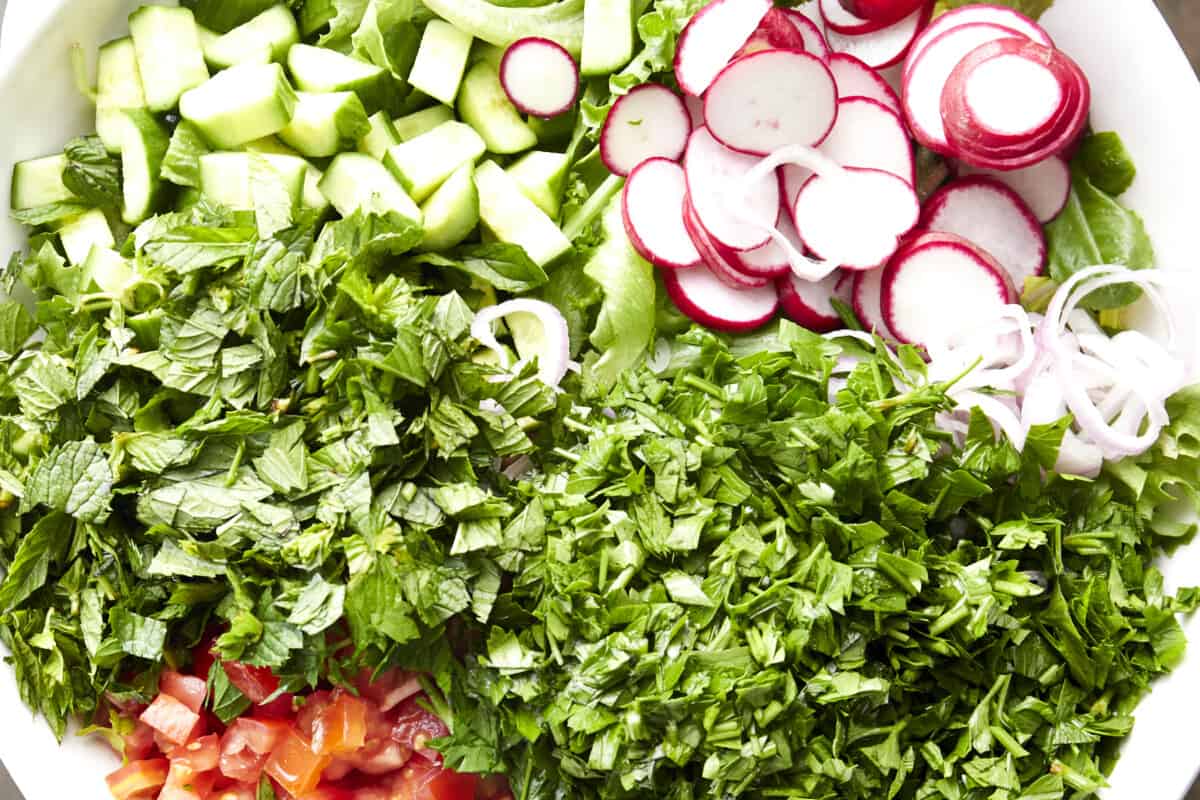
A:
130;6;209;112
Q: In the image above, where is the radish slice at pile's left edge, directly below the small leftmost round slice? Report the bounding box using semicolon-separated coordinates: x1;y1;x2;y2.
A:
622;158;700;269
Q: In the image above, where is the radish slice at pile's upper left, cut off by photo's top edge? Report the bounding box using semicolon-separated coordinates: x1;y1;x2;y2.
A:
674;0;772;97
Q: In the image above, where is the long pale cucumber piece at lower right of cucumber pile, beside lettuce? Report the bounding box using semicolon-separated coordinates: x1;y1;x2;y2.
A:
475;161;571;266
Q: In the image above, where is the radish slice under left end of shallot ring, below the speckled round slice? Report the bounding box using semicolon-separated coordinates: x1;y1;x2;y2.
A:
683;128;780;251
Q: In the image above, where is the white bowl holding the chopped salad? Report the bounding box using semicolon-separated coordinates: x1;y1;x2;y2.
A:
0;0;1200;800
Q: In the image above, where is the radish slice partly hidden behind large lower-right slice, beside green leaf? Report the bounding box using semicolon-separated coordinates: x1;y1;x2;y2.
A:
922;175;1046;291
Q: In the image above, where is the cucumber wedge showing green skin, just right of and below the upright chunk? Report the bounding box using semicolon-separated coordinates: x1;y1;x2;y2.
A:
179;64;296;148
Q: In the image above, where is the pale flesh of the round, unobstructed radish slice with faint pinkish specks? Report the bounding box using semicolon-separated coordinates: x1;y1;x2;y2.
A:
704;50;838;155
